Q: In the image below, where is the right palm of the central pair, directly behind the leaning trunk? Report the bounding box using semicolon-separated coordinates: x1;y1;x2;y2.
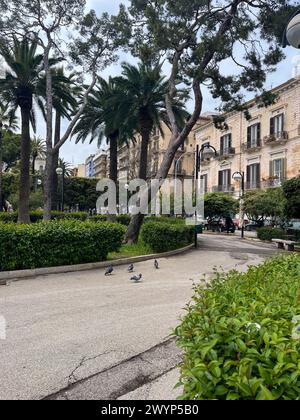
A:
112;63;188;243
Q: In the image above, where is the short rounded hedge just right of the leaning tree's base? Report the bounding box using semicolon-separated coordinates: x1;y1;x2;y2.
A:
141;221;195;252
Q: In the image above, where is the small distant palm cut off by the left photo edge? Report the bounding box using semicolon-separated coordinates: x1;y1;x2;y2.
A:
0;102;18;212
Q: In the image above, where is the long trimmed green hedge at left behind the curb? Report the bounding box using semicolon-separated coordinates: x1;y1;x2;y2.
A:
0;220;125;271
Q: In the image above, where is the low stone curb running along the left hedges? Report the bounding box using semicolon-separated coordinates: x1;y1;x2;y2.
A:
0;244;194;285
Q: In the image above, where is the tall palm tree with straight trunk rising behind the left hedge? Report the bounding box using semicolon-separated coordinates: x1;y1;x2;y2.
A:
0;37;60;223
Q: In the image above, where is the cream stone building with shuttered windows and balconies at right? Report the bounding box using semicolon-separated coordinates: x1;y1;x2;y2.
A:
194;77;300;196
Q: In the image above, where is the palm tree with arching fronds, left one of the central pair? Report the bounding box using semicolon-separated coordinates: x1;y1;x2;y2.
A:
72;77;130;184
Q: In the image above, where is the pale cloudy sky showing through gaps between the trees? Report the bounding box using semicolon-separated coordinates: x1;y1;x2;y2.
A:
47;0;300;165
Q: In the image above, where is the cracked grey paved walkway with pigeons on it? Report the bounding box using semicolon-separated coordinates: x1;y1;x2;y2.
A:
0;235;282;399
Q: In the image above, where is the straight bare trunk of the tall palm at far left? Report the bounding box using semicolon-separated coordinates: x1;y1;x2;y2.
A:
18;107;30;223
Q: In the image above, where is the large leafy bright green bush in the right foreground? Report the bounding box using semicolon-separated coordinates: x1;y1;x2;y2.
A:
176;254;300;400
